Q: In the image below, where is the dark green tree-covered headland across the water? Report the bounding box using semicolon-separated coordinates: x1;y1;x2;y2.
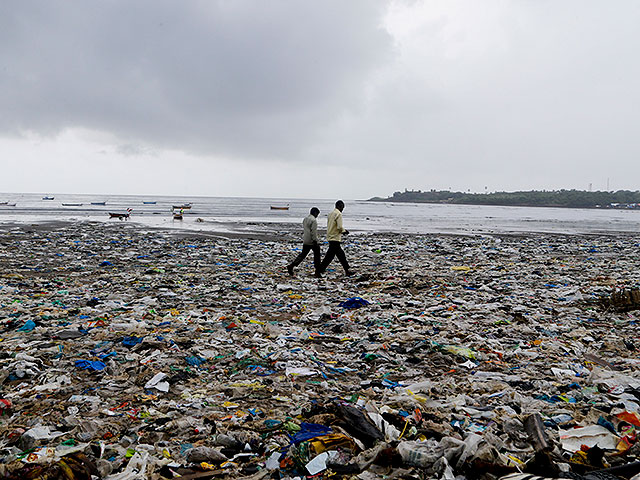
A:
369;190;640;208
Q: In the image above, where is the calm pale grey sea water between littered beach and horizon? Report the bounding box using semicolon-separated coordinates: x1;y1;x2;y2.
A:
0;193;640;234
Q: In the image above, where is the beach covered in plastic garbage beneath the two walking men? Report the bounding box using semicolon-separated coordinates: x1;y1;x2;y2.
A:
0;222;640;480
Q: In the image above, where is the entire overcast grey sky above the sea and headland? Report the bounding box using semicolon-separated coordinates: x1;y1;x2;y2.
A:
0;0;640;199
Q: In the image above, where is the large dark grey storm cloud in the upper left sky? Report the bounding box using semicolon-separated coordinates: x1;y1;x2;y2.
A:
0;0;391;158
